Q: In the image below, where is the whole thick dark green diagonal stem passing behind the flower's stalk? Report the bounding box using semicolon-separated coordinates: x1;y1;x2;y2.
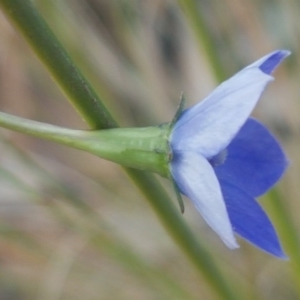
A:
0;0;240;299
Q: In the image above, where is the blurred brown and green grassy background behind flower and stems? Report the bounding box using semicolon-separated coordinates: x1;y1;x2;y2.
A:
0;0;300;300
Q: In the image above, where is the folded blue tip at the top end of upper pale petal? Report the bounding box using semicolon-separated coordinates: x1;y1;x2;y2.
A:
249;50;291;74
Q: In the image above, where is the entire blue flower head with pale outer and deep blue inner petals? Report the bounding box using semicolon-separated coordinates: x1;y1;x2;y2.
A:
170;50;290;258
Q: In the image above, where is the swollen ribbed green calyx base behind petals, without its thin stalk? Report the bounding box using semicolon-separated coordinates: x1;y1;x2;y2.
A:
75;123;172;177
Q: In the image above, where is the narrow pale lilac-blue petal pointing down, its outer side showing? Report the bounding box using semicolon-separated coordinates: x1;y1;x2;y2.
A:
171;152;238;248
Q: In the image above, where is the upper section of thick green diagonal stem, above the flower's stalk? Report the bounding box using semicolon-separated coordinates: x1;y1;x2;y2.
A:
0;0;117;128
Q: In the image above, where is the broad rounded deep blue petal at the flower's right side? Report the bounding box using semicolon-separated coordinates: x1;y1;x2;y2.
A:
214;119;288;197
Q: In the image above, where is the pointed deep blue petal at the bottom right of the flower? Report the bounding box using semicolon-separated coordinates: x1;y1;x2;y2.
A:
220;181;287;258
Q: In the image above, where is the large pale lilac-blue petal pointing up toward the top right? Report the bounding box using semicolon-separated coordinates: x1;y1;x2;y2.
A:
171;54;288;158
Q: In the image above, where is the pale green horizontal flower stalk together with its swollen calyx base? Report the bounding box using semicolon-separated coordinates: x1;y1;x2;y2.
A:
0;112;170;177
